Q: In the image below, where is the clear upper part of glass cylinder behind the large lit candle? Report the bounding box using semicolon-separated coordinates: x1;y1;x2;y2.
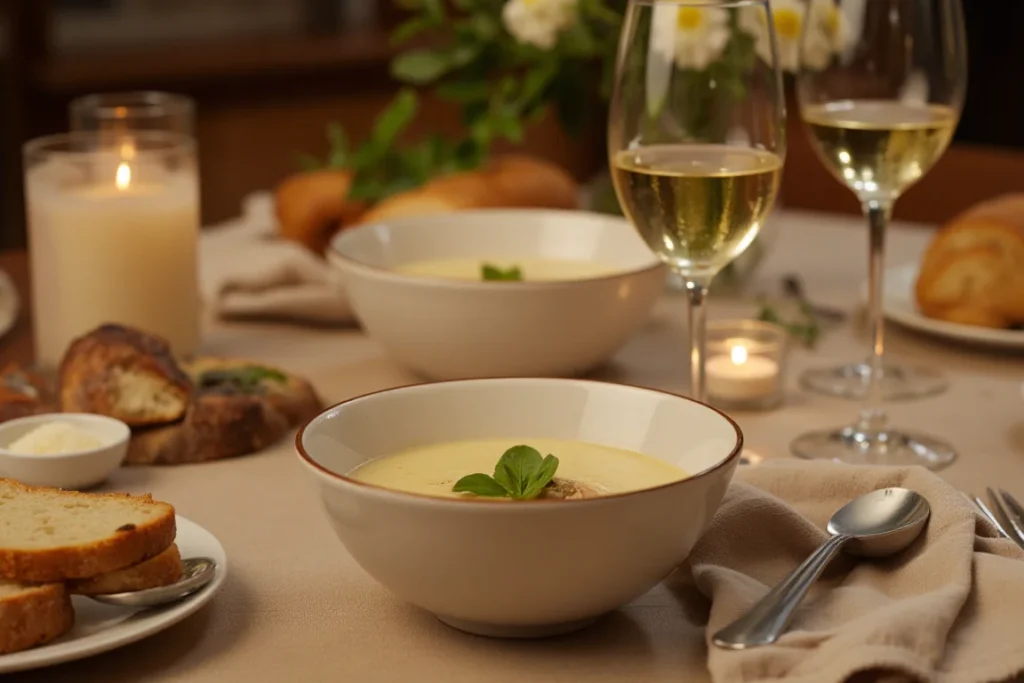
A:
69;91;196;138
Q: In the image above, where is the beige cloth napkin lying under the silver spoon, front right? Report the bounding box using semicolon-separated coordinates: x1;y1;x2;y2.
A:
670;462;1024;683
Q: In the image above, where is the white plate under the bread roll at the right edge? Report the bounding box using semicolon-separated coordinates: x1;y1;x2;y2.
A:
882;263;1024;349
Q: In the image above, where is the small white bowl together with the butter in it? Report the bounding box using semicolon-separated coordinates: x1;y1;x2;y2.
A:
0;413;130;489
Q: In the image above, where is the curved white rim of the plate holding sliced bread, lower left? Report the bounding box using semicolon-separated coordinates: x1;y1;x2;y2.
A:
0;514;227;674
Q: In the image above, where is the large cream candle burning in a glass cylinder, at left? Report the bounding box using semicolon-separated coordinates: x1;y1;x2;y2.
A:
24;131;200;369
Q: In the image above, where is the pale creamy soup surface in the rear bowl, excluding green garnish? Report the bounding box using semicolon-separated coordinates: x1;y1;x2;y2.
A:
394;258;621;282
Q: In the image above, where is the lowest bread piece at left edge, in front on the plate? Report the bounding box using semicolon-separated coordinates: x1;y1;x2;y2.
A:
0;580;75;654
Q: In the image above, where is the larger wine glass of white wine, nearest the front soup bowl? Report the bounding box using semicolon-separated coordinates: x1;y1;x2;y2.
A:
608;0;785;400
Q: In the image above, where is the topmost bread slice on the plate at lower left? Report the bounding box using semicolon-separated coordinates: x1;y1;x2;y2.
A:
0;479;175;583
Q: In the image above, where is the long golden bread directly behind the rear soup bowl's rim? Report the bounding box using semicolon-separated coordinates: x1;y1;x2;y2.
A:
359;155;579;223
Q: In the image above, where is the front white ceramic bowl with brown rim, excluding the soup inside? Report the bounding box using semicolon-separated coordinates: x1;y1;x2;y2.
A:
296;378;742;637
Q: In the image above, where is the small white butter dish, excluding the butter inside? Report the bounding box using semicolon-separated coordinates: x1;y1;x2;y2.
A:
0;413;131;489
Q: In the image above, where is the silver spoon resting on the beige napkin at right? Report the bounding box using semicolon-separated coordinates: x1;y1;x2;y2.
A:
712;488;931;650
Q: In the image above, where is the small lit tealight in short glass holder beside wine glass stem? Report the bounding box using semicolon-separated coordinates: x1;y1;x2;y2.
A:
705;319;788;411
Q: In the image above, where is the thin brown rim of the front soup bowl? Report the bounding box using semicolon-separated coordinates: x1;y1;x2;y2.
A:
295;377;743;509
